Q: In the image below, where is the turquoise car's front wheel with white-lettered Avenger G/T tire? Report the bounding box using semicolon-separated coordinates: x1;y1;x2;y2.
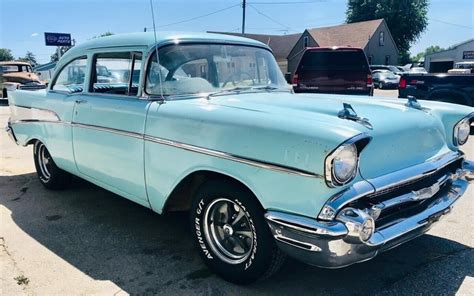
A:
190;180;285;284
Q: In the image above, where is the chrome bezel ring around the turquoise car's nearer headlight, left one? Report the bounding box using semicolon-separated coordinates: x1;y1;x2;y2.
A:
324;134;372;187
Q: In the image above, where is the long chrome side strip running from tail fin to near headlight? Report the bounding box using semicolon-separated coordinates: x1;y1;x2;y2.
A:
12;120;323;178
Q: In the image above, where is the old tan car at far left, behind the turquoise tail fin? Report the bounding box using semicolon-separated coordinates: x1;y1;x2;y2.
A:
0;61;46;98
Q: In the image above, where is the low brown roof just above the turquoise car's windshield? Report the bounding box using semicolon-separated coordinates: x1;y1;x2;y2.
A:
209;32;301;58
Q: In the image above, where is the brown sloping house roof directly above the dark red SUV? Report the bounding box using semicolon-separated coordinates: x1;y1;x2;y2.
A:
308;19;384;48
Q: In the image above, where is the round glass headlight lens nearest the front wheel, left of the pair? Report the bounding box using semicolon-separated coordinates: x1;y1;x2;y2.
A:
332;144;358;185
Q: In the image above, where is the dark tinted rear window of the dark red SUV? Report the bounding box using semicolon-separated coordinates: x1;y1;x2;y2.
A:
298;50;369;71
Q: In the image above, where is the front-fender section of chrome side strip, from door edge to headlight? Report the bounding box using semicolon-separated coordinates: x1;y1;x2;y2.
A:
145;135;323;178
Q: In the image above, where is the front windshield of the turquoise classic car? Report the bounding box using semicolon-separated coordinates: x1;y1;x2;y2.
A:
146;44;288;96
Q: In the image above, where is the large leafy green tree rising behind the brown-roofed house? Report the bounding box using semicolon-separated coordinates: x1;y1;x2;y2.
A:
346;0;429;57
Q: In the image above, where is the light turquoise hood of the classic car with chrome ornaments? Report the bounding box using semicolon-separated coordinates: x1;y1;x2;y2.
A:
205;92;463;179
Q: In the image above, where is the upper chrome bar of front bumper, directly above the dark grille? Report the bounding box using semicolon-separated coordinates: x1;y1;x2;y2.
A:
318;151;464;220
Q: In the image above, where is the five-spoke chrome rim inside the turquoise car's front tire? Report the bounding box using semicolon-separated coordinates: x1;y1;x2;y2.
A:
204;198;254;264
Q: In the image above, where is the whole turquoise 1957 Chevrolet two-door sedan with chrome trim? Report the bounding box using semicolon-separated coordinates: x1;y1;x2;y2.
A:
7;33;474;283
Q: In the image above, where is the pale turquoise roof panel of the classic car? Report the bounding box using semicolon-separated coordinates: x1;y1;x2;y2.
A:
66;31;270;55
